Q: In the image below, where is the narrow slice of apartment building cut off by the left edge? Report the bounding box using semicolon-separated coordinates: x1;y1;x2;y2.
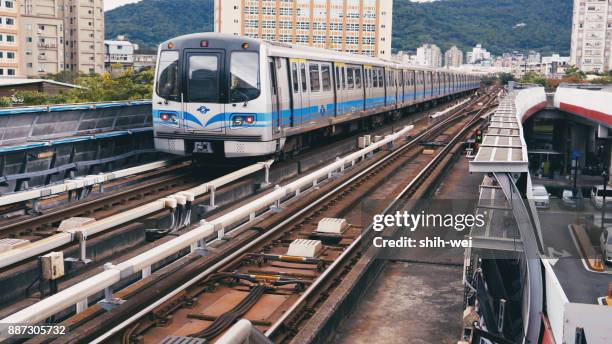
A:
0;0;22;77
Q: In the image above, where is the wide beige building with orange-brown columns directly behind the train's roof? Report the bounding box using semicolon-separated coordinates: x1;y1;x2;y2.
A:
215;0;393;60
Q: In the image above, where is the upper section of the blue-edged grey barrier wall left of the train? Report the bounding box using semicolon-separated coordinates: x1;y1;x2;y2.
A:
0;101;152;146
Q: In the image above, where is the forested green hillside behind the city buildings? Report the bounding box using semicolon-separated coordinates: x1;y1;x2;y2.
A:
106;0;573;55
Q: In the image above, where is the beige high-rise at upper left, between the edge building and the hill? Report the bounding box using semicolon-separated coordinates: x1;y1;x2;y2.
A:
20;0;104;76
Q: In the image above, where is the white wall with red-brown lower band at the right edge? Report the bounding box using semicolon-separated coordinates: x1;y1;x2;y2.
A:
555;87;612;128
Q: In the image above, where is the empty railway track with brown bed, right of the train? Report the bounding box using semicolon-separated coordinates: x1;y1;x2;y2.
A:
30;87;495;343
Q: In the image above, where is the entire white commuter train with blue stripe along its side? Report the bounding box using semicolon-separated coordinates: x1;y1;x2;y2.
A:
153;33;480;159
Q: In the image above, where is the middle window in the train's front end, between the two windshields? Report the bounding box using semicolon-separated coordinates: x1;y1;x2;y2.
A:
188;55;219;103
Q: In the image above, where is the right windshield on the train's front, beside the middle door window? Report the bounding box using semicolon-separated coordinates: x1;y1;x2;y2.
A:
230;52;261;103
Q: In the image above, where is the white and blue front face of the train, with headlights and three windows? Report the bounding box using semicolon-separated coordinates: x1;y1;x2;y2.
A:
153;34;279;159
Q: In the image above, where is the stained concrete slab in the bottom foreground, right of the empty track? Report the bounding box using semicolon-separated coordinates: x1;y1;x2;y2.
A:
333;263;463;344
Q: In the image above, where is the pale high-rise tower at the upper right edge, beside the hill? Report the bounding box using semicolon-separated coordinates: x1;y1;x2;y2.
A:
571;0;612;72
